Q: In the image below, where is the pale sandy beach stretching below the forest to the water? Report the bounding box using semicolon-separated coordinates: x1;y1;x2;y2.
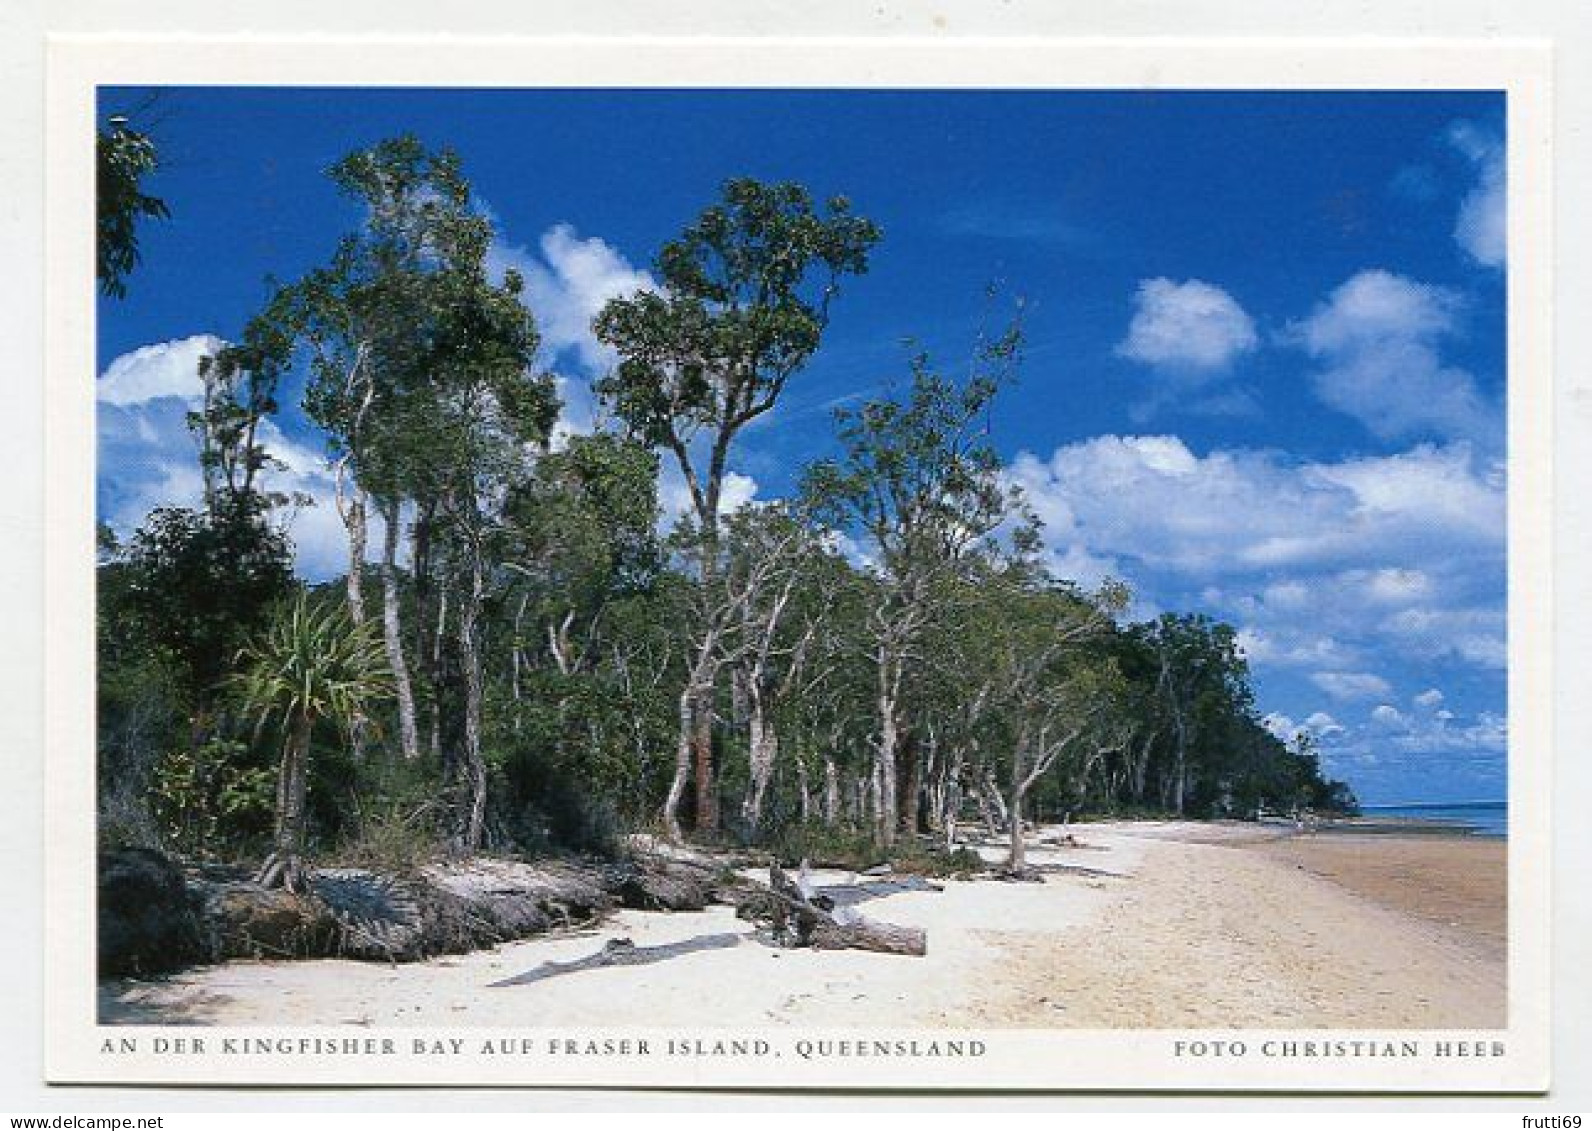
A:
100;824;1504;1029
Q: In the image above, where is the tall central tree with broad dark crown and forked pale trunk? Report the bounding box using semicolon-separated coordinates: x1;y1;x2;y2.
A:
594;178;879;830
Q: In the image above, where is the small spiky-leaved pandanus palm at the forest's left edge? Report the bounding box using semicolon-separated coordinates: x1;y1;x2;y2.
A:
236;594;390;890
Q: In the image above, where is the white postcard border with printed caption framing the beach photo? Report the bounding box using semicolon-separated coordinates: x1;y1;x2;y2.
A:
45;37;1552;1093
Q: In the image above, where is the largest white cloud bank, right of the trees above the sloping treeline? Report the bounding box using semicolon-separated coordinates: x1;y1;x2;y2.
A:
1008;436;1506;681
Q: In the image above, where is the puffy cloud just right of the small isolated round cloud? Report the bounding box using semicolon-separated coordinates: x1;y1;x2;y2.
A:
1288;271;1503;444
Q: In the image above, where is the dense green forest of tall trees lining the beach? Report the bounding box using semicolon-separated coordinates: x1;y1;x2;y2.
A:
97;123;1353;887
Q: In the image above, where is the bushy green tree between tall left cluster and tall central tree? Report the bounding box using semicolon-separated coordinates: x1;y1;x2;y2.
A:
492;432;659;816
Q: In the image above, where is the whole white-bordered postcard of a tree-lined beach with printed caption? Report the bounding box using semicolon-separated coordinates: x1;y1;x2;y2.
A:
46;38;1552;1093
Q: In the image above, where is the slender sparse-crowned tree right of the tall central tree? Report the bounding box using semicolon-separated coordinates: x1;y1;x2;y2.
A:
804;325;1020;844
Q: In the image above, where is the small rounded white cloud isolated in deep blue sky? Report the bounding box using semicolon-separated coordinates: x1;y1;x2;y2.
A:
1116;279;1259;378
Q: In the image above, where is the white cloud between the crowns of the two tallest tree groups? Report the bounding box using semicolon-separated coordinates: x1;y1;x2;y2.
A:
487;225;657;373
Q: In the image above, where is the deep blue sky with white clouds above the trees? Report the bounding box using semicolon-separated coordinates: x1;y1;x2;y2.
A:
99;89;1506;801
